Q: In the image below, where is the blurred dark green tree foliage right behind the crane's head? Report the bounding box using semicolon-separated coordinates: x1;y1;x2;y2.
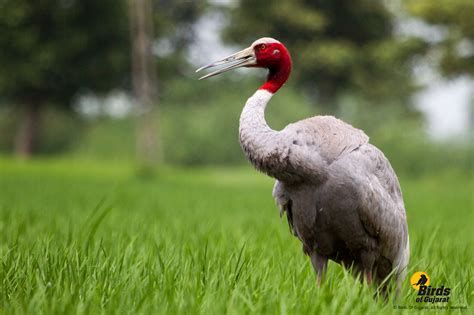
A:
225;0;426;112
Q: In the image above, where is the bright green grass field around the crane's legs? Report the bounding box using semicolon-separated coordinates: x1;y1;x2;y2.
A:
0;158;474;314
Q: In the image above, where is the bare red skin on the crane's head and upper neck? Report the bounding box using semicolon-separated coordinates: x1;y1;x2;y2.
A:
255;43;292;94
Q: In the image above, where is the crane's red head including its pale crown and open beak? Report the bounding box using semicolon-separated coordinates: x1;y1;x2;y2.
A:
196;37;291;93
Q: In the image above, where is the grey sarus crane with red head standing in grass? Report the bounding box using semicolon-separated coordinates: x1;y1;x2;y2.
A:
196;37;410;285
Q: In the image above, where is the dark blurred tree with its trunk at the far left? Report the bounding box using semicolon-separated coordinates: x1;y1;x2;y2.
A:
0;0;129;155
